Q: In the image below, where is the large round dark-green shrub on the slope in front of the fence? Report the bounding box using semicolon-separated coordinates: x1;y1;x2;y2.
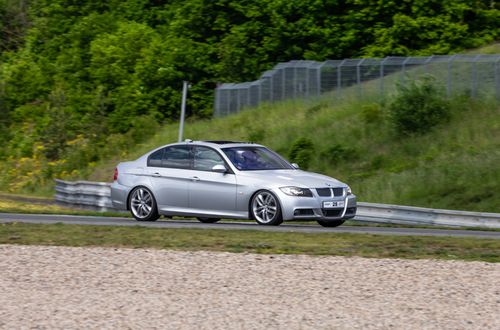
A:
389;75;450;135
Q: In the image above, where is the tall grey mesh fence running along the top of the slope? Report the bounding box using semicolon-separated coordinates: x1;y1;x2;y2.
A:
214;55;500;117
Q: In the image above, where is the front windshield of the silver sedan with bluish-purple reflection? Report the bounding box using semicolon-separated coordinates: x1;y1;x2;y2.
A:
222;147;294;171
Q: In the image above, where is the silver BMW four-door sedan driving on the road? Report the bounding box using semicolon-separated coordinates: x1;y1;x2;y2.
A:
111;140;356;227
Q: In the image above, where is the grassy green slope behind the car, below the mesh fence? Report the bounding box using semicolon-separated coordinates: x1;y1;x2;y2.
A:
89;74;500;212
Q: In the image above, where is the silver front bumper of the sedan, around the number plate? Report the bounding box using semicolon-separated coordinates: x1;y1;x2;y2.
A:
274;189;357;221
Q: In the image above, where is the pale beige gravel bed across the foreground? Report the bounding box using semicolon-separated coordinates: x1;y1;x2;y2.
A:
0;245;500;329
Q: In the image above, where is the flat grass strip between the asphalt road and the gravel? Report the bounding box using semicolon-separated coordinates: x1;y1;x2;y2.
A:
0;223;500;262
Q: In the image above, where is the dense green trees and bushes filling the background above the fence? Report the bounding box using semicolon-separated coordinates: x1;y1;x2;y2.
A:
0;0;500;190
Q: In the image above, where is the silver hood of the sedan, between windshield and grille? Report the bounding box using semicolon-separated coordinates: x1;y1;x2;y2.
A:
236;170;346;188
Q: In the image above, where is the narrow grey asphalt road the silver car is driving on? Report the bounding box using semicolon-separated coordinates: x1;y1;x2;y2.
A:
0;213;500;239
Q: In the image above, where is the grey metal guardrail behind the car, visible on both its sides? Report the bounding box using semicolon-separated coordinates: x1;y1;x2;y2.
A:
55;180;500;228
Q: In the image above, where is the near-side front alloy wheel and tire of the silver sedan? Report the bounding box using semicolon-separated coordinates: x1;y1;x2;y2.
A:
250;190;283;226
